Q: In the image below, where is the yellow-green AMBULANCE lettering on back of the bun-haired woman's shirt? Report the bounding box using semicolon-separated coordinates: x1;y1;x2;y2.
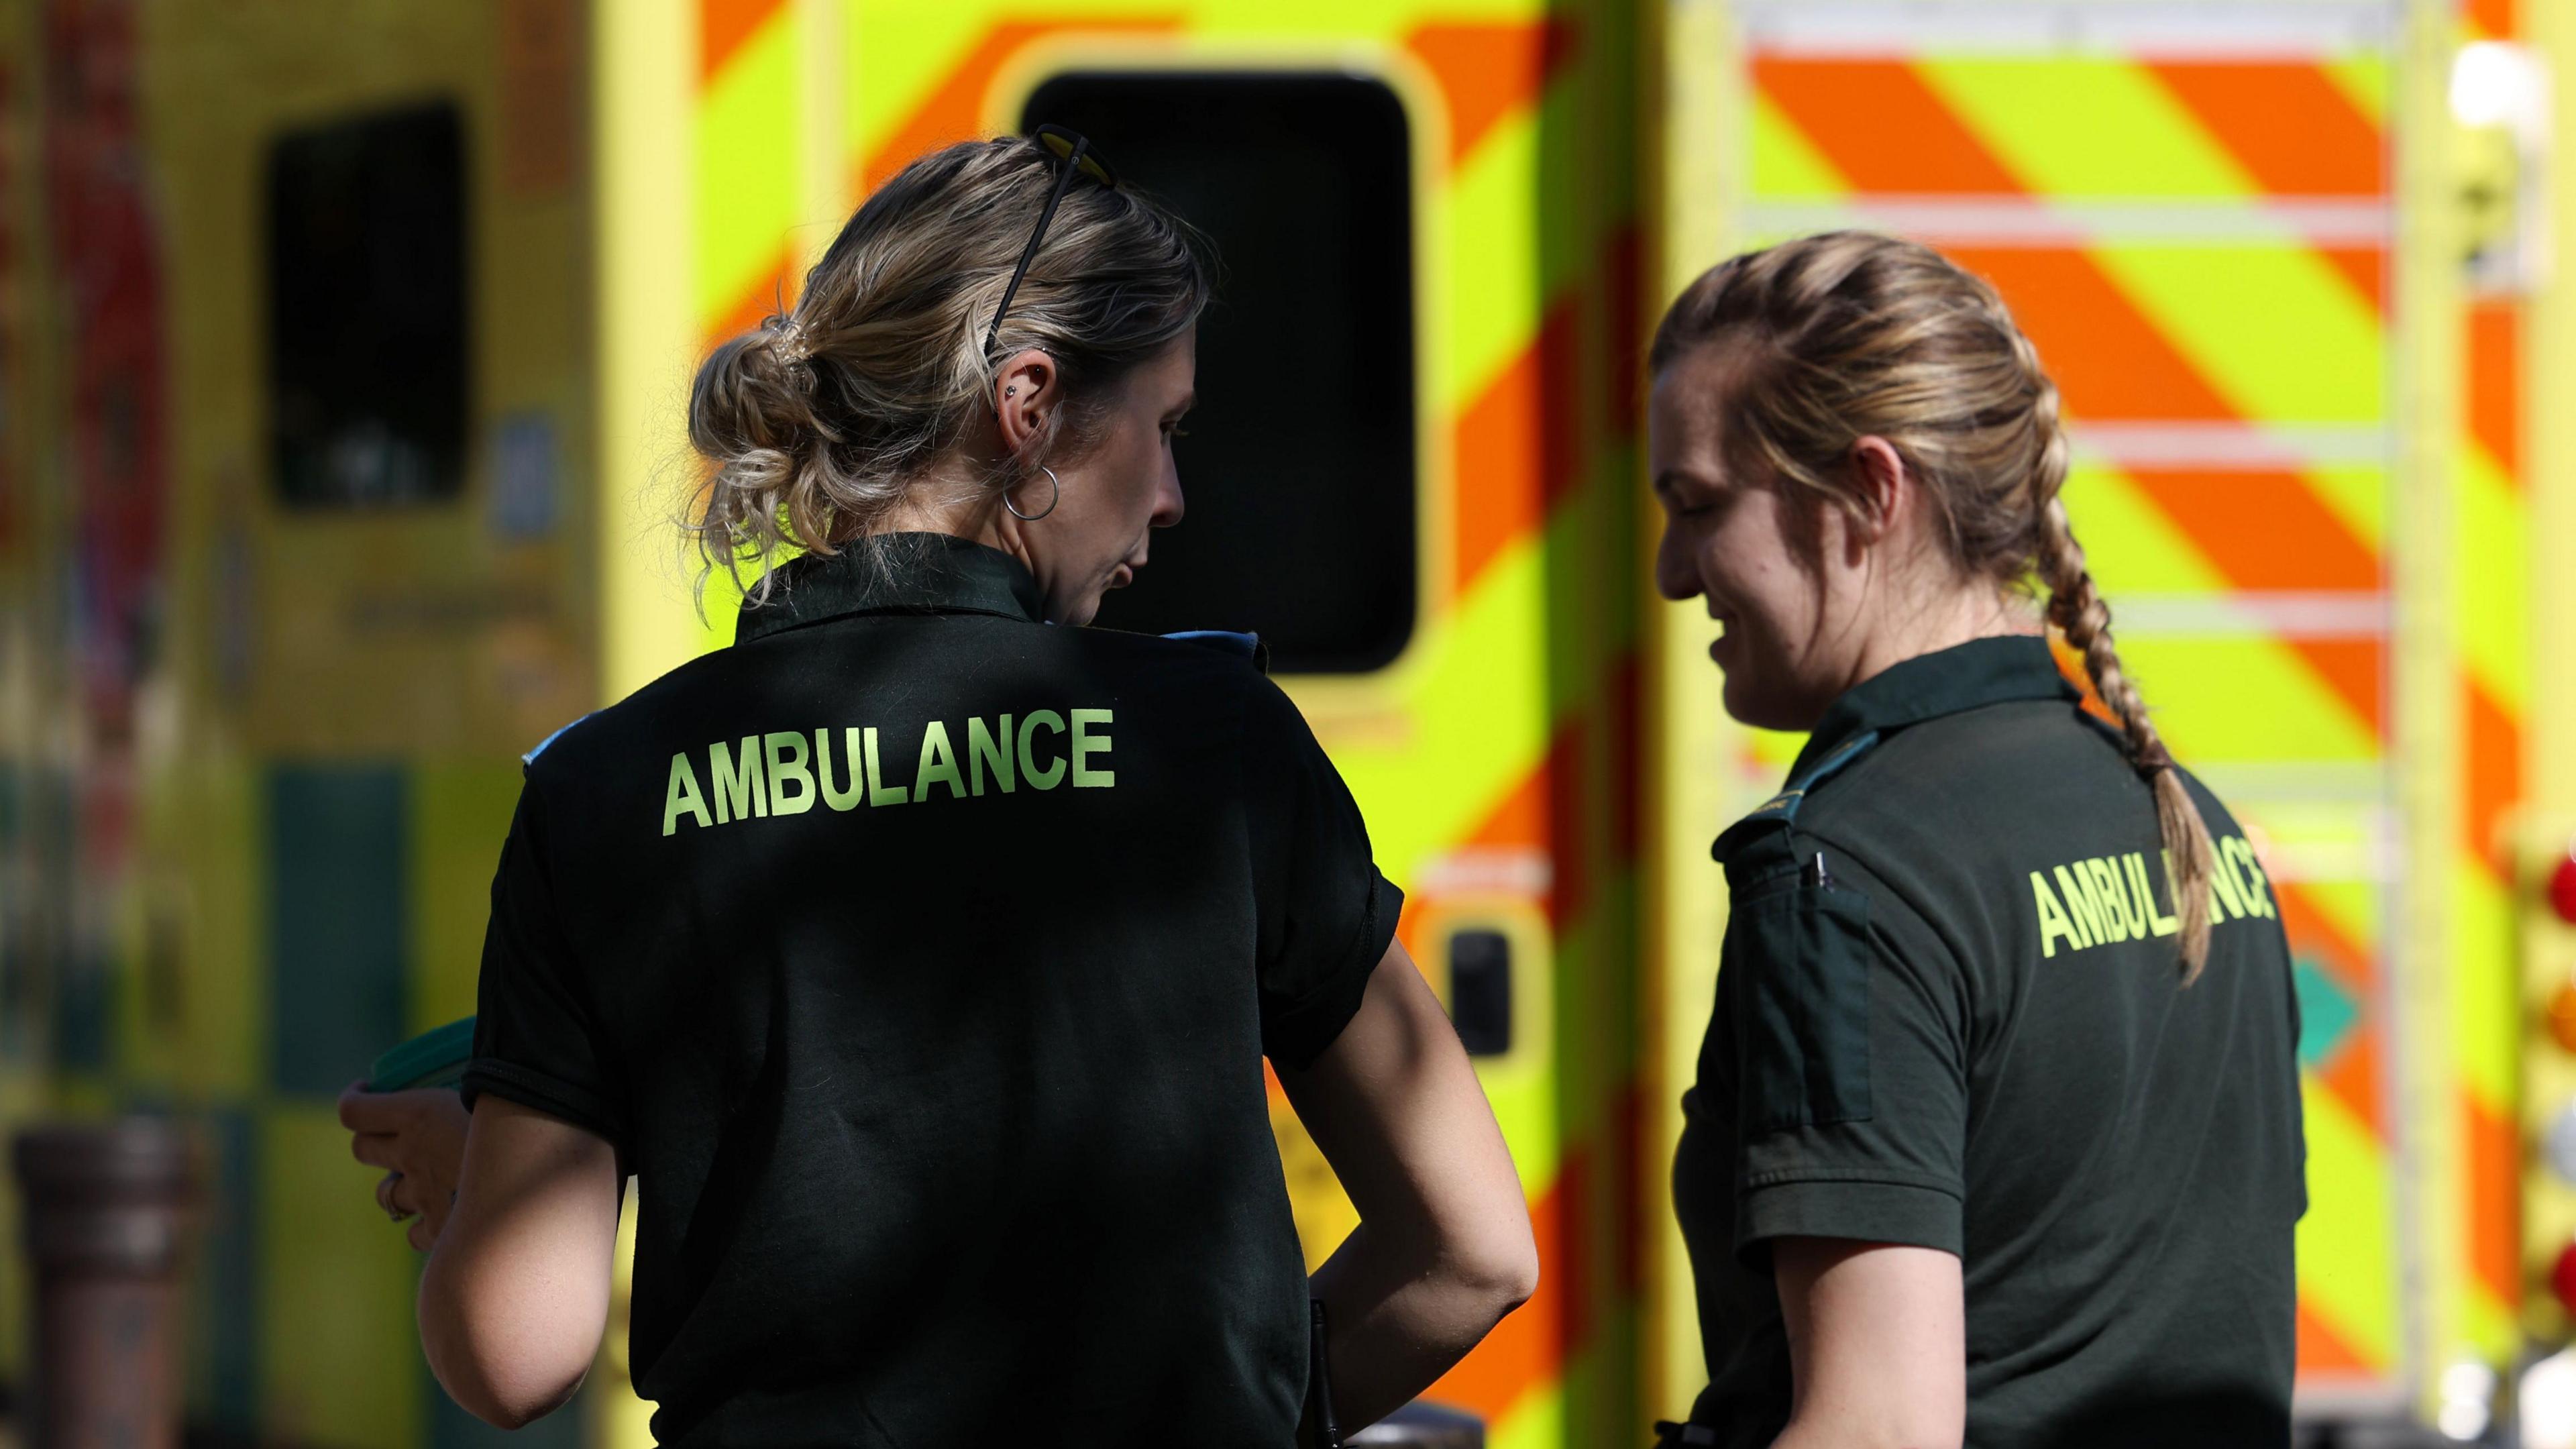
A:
662;709;1118;835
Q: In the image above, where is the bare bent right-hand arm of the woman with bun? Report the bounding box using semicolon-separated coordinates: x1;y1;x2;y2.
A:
1280;944;1538;1428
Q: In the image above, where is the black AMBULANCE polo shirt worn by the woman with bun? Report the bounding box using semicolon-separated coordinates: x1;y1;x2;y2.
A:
466;534;1401;1446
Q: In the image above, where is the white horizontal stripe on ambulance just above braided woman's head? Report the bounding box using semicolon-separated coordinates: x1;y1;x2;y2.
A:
1744;196;2396;248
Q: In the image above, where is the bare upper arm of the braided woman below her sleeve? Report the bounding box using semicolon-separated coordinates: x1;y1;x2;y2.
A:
1772;1238;1968;1449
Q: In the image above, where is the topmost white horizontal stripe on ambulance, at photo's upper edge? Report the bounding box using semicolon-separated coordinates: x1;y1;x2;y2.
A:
1739;0;2406;59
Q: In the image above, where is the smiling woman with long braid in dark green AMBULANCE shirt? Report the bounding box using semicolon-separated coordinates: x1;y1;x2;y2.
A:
1649;232;2306;1449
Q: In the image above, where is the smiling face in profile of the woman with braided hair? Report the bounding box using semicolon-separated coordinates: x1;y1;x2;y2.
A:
1646;348;1855;730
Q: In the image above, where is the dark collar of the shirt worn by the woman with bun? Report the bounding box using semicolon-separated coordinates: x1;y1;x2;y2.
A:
734;534;1046;645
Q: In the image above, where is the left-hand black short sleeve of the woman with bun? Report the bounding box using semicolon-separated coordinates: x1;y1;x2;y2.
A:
464;782;626;1147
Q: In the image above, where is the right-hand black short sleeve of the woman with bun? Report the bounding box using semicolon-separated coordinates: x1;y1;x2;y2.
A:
1239;678;1404;1067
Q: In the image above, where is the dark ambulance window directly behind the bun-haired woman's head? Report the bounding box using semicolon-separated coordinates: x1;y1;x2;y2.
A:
1025;72;1417;673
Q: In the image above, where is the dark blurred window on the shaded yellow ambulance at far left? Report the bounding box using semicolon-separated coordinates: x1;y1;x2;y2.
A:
268;103;466;508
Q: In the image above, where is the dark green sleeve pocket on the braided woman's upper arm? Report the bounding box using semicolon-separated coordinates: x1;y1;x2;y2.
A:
1718;869;1870;1137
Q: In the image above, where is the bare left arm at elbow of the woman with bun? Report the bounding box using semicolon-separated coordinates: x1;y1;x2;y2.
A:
420;1095;621;1428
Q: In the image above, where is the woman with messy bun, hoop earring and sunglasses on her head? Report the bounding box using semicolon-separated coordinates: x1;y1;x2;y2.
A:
343;129;1538;1446
